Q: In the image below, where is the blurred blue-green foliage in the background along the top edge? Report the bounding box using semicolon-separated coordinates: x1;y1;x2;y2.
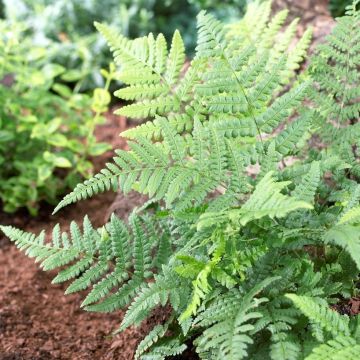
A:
2;0;247;92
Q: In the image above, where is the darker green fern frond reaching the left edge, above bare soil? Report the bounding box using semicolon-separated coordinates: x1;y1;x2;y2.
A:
1;215;173;311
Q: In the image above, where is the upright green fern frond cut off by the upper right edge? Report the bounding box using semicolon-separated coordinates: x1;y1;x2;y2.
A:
310;1;360;172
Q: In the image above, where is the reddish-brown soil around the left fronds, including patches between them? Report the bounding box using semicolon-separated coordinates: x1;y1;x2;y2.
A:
0;111;161;360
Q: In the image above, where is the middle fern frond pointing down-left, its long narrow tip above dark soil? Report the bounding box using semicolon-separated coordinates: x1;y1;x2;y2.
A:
54;118;232;212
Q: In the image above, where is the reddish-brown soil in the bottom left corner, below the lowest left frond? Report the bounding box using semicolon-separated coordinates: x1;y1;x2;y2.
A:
0;246;148;360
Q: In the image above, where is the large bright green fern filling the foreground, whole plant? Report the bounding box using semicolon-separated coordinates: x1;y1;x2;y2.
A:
1;2;360;360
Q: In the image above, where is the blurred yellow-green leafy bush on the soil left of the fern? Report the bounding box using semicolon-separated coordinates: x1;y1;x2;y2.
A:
0;21;114;214
